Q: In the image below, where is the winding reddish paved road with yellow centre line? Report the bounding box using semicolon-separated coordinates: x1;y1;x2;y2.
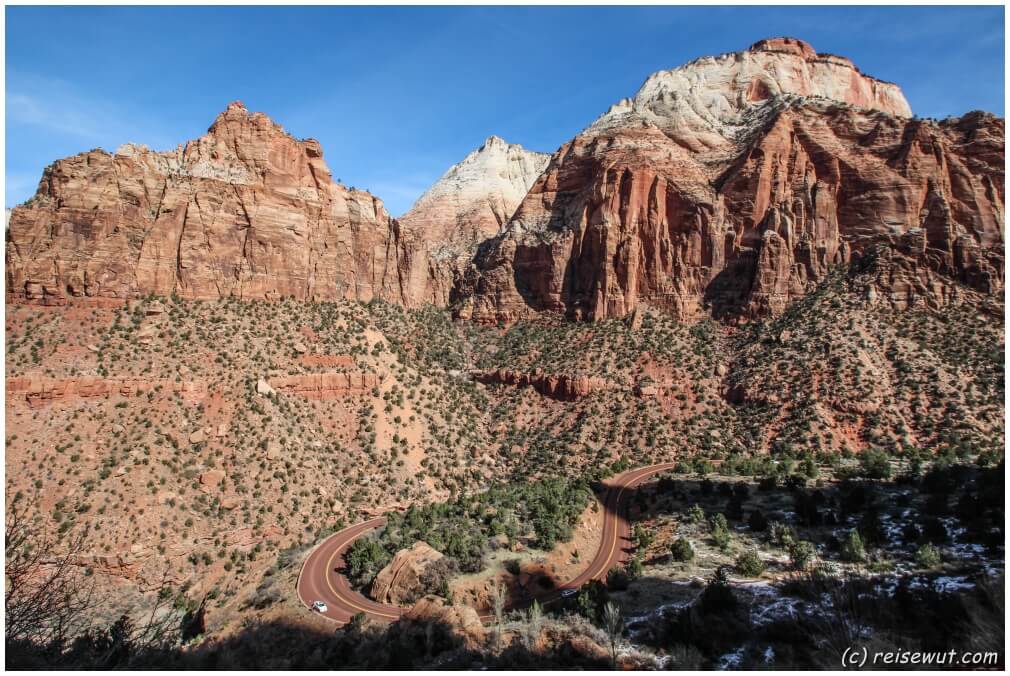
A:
298;463;674;622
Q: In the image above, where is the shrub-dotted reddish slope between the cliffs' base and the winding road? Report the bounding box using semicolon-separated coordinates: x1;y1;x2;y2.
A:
6;247;1005;638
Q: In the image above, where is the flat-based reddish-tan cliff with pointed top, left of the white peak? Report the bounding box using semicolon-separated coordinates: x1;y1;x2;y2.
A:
7;103;413;304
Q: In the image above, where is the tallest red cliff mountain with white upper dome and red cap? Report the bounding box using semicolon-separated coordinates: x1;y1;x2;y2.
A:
453;39;1005;321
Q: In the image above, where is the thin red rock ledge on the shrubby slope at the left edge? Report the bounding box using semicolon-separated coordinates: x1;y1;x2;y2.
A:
6;376;207;407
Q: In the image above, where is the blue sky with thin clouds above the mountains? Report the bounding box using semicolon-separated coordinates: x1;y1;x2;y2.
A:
5;6;1004;214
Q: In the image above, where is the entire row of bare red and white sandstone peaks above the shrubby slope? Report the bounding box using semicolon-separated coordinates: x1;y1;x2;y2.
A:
6;38;1005;322
